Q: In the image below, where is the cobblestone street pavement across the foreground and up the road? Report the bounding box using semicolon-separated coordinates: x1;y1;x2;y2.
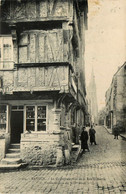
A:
0;126;126;194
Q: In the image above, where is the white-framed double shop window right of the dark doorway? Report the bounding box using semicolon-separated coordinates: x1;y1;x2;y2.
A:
26;106;46;131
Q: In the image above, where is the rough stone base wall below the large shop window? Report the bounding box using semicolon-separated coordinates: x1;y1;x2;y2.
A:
21;132;71;166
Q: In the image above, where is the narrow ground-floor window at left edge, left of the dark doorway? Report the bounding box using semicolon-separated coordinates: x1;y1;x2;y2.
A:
0;105;6;131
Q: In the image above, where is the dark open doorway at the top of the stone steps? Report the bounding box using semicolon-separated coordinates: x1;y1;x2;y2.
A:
11;111;23;143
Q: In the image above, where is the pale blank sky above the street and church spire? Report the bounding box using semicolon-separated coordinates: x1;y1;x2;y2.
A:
85;0;126;110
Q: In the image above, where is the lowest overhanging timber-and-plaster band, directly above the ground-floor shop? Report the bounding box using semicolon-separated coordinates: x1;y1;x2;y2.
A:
0;63;77;99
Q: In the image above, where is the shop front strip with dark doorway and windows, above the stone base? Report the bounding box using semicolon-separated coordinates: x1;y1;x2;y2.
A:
0;100;53;137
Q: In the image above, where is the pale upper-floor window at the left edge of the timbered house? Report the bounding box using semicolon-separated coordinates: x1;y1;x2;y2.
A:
0;36;14;69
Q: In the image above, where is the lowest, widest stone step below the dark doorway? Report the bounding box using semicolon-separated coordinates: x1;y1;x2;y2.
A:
0;163;27;171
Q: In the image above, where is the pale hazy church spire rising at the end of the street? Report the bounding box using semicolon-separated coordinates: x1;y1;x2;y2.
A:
87;69;98;124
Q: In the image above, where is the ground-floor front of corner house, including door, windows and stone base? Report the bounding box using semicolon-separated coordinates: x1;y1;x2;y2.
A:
0;99;71;165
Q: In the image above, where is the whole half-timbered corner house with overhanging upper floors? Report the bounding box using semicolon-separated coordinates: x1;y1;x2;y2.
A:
0;0;88;165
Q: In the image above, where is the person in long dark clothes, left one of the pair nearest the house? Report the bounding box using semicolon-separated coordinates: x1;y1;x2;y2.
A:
80;127;90;153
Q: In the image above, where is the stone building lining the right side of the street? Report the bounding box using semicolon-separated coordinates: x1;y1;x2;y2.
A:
106;63;126;132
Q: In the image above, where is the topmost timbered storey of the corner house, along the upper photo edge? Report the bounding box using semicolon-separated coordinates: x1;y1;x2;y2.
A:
1;0;88;23
